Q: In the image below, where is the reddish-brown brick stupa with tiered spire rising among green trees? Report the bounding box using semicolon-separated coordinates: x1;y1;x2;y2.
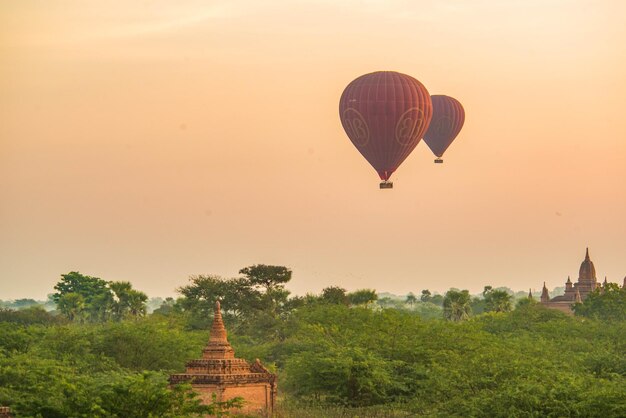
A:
170;301;276;415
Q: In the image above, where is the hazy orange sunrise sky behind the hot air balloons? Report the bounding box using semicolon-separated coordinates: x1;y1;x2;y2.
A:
0;0;626;299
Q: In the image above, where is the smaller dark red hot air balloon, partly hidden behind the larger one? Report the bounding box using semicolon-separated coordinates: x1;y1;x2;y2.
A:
424;95;465;164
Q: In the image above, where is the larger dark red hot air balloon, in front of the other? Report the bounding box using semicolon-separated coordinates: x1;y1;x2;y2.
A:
339;71;432;189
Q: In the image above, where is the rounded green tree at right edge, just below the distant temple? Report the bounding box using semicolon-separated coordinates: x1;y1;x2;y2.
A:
574;283;626;321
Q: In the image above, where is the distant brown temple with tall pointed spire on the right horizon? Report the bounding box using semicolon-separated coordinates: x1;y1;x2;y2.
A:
541;248;626;314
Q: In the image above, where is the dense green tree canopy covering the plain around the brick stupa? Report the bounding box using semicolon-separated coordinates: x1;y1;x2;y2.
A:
0;265;626;418
